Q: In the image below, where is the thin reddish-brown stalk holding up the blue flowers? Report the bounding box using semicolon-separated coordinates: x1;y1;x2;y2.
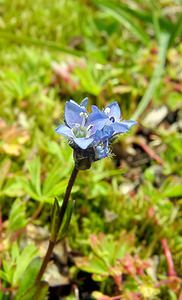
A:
36;167;78;284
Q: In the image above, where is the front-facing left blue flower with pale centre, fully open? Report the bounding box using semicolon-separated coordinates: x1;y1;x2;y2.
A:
56;98;107;149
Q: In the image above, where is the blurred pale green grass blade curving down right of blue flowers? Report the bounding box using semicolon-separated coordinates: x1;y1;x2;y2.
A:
132;33;170;119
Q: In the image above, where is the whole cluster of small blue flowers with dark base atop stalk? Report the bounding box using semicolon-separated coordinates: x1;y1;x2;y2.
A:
56;98;136;169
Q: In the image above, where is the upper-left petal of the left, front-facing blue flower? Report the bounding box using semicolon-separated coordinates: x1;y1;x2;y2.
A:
65;100;85;128
